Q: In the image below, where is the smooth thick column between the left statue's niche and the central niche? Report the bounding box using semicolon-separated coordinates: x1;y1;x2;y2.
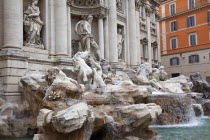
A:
54;0;68;57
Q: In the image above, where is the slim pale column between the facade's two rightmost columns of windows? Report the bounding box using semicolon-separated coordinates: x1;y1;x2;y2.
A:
146;7;152;64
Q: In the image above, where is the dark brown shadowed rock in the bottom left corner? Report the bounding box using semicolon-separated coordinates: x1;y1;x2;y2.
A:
0;103;36;137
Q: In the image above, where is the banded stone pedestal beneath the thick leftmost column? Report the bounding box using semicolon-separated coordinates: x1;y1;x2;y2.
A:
0;48;28;103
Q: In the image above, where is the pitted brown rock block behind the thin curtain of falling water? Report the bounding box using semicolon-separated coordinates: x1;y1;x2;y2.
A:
147;94;194;125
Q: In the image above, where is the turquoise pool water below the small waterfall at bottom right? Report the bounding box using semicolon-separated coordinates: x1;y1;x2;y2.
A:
151;117;210;140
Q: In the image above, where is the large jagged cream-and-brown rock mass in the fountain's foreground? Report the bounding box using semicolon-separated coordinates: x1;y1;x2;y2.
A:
17;68;162;140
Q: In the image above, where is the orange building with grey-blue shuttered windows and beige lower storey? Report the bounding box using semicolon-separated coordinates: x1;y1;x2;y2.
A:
159;0;210;82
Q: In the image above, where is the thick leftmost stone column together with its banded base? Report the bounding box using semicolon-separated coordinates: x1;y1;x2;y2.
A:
0;0;28;103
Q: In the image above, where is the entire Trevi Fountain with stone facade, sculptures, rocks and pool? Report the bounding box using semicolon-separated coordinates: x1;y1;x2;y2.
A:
0;0;210;140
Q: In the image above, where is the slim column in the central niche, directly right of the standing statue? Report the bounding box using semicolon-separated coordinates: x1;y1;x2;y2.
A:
98;15;104;58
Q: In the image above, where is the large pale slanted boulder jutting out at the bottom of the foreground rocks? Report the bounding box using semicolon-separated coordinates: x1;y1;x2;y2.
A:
52;102;89;133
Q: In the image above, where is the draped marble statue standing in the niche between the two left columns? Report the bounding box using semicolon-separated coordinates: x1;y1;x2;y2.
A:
24;0;44;47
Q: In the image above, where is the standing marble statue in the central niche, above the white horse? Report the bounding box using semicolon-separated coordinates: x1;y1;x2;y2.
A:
75;15;102;61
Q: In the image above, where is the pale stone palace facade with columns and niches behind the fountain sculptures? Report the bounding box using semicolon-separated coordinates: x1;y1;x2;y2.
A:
0;0;160;102
